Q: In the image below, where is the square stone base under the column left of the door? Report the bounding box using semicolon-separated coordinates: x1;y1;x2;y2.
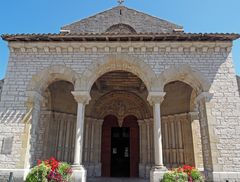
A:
72;165;87;182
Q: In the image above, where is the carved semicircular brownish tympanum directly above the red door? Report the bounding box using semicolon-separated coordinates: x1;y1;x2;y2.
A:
92;91;152;122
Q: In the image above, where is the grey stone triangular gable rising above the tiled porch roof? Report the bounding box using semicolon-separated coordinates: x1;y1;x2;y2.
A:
61;6;183;33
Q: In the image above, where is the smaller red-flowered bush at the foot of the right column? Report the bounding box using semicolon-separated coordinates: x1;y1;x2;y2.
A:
162;165;204;182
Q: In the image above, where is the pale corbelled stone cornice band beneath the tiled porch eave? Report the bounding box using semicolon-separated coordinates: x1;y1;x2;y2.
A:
9;41;232;54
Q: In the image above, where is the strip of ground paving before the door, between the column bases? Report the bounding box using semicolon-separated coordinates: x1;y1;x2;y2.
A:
87;177;149;182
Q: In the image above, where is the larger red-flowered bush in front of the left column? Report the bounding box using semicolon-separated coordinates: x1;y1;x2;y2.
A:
26;157;72;182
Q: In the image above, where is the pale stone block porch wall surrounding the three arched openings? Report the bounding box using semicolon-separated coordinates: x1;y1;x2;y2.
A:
0;42;240;179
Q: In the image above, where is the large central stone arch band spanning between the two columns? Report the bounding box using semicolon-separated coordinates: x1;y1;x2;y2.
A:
80;55;157;91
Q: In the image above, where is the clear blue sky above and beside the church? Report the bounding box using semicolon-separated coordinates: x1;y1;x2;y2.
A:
0;0;240;79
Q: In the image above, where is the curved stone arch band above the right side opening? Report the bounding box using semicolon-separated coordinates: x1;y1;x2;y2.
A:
158;65;211;94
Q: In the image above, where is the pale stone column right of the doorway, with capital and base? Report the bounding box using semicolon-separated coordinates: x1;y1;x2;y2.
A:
148;92;166;182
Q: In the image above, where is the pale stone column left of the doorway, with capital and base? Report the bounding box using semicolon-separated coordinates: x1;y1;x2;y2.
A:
72;91;91;182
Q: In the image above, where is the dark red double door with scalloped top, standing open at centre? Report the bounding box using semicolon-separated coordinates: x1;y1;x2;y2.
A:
101;115;139;177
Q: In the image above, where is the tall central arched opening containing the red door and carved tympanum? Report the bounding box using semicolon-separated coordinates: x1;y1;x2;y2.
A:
84;71;153;177
